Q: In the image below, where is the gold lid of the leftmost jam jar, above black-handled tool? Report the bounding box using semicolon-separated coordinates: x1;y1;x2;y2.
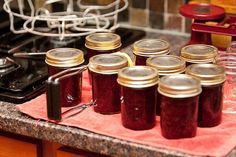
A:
45;48;84;67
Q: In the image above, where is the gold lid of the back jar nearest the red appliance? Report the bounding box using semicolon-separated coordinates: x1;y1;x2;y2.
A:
181;44;218;63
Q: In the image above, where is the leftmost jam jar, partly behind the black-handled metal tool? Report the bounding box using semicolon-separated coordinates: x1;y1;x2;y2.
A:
45;48;84;107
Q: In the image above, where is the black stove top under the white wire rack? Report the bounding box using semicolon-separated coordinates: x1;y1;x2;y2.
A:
0;11;145;103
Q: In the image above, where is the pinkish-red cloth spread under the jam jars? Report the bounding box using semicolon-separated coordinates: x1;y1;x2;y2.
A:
16;73;236;156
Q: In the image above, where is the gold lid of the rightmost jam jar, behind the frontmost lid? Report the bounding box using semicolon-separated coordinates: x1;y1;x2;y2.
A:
186;64;226;86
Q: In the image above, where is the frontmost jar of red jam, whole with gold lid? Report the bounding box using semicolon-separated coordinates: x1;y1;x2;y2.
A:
158;74;201;139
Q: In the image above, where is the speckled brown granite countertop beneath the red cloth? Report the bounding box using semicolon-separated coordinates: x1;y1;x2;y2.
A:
0;30;236;157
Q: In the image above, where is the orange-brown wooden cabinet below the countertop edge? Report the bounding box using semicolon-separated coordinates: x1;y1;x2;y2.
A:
0;131;108;157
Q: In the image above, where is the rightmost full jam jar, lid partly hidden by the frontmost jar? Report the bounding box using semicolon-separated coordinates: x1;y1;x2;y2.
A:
186;64;226;127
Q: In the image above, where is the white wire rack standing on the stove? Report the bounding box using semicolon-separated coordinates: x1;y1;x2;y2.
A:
3;0;128;39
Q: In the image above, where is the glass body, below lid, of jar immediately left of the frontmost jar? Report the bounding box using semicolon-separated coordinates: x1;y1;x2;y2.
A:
121;85;157;130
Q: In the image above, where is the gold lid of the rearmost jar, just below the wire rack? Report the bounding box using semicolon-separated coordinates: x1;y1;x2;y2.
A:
85;33;121;50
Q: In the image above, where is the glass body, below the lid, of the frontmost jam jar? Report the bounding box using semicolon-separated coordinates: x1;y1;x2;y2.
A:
160;95;199;139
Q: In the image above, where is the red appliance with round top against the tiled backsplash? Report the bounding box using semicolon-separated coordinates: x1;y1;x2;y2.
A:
179;3;236;49
